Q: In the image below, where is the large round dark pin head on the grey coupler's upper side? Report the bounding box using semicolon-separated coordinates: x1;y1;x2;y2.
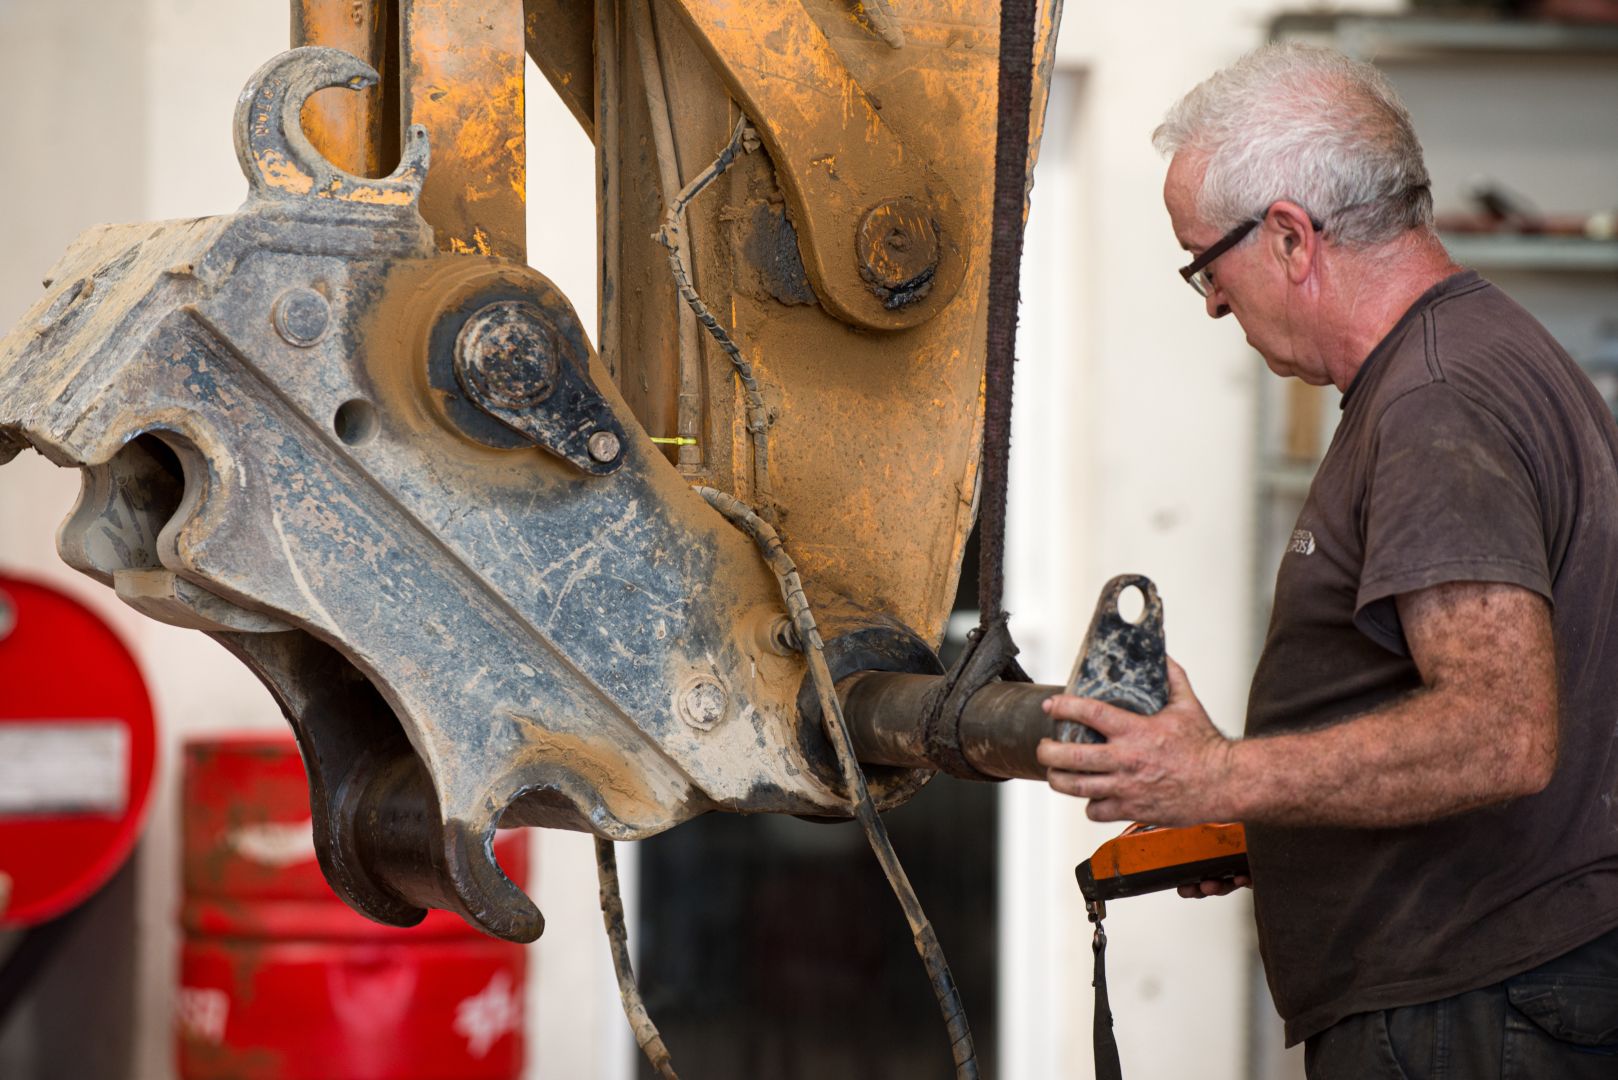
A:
455;300;563;408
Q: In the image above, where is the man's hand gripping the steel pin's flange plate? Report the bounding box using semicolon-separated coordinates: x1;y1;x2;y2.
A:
1037;659;1233;826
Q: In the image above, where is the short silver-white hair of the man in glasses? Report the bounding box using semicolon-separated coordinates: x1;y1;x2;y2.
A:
1152;42;1432;246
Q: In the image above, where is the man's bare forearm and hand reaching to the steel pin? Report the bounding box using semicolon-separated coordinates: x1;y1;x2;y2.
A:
1039;583;1557;827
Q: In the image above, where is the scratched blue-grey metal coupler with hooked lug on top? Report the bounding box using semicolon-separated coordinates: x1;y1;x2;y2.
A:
0;52;873;936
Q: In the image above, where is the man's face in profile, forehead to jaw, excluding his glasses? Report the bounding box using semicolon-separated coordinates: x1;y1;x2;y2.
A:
1163;154;1328;385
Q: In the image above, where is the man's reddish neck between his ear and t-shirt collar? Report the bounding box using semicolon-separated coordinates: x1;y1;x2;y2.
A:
1320;232;1461;392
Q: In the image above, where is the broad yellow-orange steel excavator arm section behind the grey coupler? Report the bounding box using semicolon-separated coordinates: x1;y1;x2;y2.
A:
594;0;1060;643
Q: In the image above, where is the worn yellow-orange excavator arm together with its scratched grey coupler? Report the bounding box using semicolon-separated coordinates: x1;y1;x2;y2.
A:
0;0;1058;939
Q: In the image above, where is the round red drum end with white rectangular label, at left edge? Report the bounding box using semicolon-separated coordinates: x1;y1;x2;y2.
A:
0;576;157;928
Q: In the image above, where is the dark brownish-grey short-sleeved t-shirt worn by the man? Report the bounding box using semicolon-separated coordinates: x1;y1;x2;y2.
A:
1247;272;1618;1043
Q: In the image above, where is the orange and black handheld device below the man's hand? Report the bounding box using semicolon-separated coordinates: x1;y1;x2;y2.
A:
1073;823;1247;904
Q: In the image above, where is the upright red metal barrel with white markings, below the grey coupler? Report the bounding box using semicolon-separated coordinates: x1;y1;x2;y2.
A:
176;737;527;1080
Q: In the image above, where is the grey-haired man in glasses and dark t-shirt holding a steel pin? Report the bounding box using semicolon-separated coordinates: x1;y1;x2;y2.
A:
1040;45;1618;1080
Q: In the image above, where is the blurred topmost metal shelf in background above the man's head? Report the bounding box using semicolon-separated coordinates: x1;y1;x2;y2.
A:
1270;11;1618;60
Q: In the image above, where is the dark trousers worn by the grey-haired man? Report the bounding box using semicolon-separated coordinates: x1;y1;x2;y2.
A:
1304;931;1618;1080
